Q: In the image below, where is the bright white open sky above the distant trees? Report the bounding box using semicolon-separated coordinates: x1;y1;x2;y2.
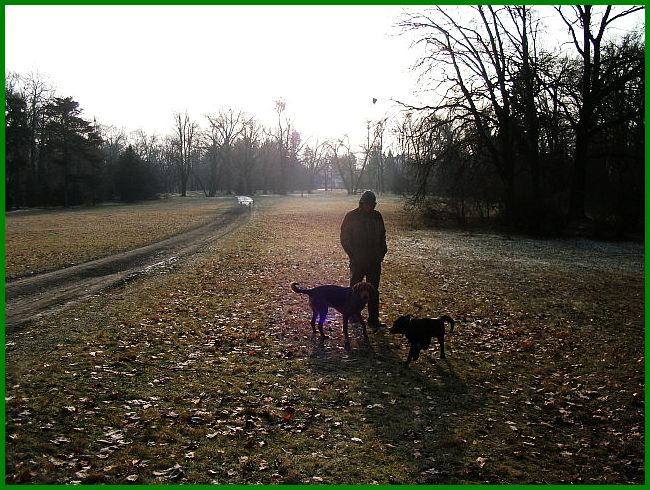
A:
5;5;417;146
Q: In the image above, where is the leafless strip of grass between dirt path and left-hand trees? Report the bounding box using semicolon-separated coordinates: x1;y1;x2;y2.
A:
5;196;234;279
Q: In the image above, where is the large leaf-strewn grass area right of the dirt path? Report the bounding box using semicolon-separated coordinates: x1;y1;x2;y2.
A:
5;191;645;484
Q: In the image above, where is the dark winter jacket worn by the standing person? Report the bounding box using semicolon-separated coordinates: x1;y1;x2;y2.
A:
341;207;388;264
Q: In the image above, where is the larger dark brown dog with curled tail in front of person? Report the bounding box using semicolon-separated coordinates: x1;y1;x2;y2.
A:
291;281;377;347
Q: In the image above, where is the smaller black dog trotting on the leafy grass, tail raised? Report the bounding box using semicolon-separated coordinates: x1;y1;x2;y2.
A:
390;315;454;366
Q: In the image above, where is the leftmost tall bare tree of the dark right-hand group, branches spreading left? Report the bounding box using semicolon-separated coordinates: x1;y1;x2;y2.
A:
401;5;540;220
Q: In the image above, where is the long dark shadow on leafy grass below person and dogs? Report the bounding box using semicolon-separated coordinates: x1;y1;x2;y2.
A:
307;327;483;484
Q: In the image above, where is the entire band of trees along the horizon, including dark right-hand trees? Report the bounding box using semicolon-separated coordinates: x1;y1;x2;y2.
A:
5;6;645;237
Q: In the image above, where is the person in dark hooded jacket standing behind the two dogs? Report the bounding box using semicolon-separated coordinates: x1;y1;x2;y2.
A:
341;191;388;330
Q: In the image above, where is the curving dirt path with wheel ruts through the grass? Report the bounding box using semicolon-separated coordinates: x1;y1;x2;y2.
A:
5;207;249;333
